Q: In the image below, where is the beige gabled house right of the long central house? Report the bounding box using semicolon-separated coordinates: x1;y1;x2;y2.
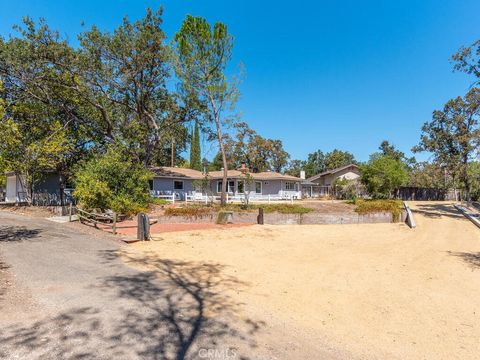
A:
302;164;360;197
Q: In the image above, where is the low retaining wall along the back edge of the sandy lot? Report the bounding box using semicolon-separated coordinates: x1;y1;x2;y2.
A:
154;211;406;225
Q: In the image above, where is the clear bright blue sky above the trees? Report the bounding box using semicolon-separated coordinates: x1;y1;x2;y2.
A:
0;0;480;160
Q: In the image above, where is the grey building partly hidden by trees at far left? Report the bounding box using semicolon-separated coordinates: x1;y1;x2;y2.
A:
4;171;73;206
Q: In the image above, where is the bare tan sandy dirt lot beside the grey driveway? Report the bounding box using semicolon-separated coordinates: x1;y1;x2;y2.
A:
124;202;480;359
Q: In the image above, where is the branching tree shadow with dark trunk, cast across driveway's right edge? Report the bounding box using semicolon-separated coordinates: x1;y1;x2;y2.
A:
100;251;263;359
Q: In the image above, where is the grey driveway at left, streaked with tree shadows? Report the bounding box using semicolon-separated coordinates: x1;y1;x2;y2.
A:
0;212;274;360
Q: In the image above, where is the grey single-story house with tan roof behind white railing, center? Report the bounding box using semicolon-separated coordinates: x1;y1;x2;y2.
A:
150;167;302;201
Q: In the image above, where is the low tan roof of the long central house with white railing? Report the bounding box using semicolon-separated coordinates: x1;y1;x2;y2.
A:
150;166;301;181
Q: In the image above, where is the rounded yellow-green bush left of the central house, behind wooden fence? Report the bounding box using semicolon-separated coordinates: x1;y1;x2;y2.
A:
74;148;152;215
